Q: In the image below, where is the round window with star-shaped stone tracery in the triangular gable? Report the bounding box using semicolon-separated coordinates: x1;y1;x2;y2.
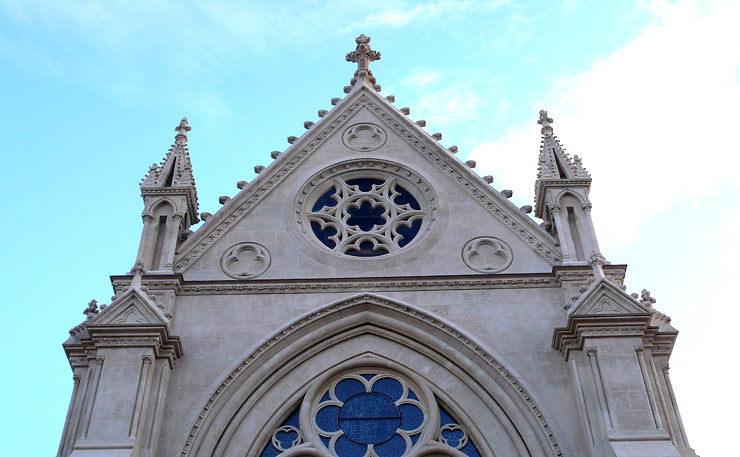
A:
296;161;437;257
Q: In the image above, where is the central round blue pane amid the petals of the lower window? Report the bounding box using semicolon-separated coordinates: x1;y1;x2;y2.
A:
339;393;401;444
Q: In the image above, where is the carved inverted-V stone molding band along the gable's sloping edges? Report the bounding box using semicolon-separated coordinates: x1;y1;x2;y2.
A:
174;89;561;273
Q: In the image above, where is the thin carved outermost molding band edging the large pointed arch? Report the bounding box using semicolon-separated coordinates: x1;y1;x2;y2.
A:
180;294;562;457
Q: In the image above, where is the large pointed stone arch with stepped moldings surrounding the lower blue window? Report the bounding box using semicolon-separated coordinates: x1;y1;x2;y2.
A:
181;294;562;457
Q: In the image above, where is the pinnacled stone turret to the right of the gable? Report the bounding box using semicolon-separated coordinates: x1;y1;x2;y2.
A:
534;110;600;264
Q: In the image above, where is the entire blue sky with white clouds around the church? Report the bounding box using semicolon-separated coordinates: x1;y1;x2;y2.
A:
0;0;740;456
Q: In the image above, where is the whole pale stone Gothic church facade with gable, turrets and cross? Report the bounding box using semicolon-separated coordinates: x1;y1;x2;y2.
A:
58;35;696;457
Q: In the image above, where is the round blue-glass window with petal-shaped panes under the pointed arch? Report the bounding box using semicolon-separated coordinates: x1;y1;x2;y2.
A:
314;373;426;457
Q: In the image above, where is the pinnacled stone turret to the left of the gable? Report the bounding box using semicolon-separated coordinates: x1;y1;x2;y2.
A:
137;117;199;272
